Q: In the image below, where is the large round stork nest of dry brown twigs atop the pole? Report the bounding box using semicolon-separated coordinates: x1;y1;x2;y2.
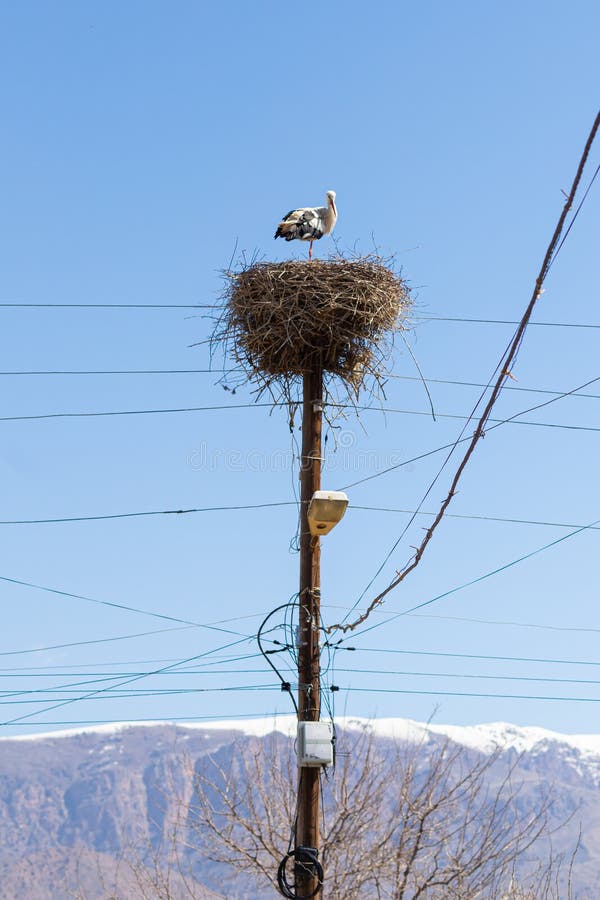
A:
213;256;410;402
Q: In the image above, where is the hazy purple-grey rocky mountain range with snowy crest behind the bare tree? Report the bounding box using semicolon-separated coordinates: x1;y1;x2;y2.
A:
0;716;600;900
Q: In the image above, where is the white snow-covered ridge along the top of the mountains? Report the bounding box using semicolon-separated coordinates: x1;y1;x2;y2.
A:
0;715;600;757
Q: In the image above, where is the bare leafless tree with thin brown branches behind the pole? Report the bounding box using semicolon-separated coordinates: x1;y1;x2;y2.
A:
187;730;572;900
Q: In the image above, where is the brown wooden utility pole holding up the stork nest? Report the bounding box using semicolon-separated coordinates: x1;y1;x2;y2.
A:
295;364;323;897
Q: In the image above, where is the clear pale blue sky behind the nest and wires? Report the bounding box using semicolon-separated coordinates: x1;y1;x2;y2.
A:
0;0;600;735
